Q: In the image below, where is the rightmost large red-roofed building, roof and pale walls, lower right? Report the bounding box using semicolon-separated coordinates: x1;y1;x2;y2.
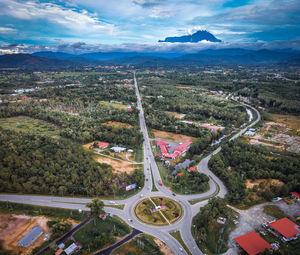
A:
268;218;300;242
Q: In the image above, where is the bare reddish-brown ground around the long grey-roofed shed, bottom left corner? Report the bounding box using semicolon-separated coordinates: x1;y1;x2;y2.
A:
0;214;49;254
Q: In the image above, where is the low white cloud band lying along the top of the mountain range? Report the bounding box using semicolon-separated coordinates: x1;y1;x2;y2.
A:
0;39;300;54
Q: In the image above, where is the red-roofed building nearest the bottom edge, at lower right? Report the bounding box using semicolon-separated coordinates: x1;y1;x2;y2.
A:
234;231;271;255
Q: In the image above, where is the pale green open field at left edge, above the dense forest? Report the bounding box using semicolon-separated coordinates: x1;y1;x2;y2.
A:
0;116;59;137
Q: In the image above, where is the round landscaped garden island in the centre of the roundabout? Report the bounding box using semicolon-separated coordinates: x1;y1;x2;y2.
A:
134;196;183;226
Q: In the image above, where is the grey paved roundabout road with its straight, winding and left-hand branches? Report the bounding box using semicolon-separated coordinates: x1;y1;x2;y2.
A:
0;73;260;255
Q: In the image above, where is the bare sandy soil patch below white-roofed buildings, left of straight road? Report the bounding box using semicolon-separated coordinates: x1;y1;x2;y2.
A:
93;155;138;174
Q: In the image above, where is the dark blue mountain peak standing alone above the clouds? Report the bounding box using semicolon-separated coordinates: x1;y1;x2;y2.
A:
158;30;221;43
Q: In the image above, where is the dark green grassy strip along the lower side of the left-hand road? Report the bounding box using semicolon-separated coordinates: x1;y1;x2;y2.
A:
0;201;88;220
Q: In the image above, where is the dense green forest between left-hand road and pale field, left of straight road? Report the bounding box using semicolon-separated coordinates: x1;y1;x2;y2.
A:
0;129;144;196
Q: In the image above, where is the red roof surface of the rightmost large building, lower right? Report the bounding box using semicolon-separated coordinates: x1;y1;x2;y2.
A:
269;218;300;238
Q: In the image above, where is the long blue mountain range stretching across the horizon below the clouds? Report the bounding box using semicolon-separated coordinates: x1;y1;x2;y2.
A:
0;48;300;68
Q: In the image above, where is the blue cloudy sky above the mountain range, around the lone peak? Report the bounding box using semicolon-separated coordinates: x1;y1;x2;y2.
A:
0;0;300;54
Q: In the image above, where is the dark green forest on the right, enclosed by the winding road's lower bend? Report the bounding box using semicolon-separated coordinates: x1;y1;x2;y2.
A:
209;139;300;205
